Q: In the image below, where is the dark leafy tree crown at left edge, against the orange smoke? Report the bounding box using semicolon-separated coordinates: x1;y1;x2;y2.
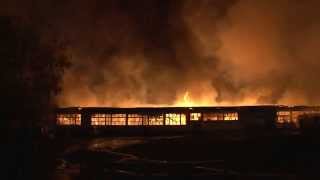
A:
0;17;68;131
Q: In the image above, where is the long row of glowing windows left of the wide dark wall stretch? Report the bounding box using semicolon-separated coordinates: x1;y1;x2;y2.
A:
57;112;238;126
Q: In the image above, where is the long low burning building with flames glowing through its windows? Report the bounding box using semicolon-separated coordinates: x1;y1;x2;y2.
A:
56;105;320;135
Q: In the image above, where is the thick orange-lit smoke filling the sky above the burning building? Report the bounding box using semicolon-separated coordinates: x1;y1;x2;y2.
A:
0;0;320;106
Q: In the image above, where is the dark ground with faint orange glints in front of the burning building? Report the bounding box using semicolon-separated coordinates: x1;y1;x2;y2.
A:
5;129;320;180
